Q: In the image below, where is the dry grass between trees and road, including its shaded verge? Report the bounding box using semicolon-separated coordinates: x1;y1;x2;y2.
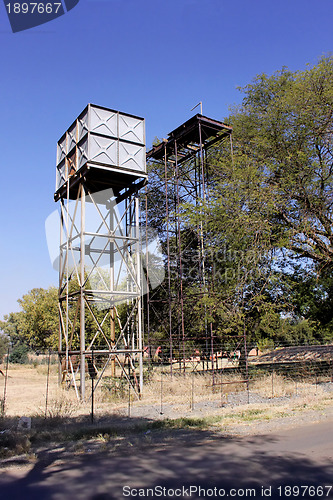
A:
0;365;333;457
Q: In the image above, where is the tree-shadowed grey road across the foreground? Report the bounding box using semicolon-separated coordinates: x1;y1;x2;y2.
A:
0;419;333;500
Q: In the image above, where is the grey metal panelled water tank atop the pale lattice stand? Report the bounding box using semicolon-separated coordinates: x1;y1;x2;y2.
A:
56;104;147;191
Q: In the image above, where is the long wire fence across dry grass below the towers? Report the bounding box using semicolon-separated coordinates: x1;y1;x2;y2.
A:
0;345;333;422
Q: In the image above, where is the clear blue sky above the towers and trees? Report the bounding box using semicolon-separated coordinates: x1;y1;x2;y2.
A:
0;0;333;319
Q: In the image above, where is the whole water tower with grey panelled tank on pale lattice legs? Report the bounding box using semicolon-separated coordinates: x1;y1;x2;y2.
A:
54;104;147;399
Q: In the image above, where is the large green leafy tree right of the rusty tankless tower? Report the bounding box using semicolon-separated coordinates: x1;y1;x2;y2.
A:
185;56;333;348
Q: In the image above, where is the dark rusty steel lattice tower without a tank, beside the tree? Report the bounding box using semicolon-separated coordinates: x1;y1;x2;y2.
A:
146;114;232;373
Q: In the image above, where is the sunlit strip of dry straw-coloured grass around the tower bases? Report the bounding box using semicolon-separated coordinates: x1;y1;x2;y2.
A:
0;365;333;428
